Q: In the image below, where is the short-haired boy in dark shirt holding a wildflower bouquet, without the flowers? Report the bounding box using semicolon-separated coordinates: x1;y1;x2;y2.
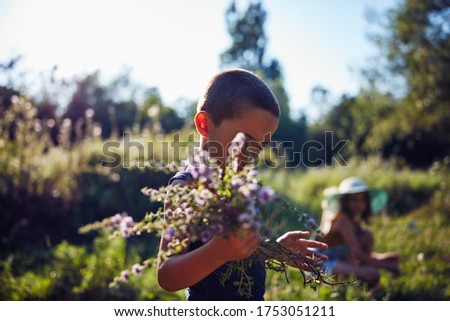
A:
158;69;327;300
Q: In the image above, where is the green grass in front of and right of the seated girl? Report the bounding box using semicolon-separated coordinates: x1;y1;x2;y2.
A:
266;205;450;301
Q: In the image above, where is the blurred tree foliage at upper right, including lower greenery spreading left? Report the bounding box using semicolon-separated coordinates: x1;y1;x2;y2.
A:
322;0;450;167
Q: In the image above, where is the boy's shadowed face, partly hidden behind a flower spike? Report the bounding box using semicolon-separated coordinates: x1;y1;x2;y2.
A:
200;106;278;164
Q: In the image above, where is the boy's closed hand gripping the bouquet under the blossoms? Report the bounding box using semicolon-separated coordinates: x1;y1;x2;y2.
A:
209;229;261;262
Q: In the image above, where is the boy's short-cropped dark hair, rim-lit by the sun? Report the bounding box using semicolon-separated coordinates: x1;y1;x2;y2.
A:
197;69;280;126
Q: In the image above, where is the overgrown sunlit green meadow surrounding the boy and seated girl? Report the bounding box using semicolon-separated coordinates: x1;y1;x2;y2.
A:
0;100;450;300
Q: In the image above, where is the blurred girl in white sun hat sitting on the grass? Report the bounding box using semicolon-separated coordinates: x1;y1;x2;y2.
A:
317;177;399;288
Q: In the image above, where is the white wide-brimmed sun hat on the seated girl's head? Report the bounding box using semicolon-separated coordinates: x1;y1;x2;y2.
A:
323;177;388;214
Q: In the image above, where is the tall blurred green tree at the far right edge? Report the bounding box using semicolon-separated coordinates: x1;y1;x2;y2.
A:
362;0;450;166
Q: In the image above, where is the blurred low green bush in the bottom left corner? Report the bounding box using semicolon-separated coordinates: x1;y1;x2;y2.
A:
0;234;184;300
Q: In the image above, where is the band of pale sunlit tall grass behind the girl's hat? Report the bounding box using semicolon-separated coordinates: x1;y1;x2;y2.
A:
261;157;445;216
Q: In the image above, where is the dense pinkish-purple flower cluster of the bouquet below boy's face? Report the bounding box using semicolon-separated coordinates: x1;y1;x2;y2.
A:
140;133;276;255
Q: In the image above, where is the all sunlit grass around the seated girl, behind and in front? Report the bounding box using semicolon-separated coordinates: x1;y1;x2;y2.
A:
262;158;450;300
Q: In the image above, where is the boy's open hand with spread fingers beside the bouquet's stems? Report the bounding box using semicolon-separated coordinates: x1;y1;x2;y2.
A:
277;231;328;270
